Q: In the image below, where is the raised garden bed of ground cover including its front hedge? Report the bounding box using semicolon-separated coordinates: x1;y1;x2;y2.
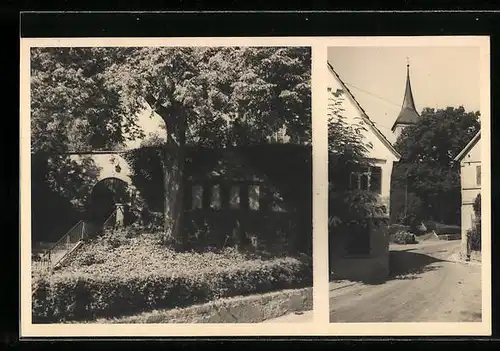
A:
33;234;312;323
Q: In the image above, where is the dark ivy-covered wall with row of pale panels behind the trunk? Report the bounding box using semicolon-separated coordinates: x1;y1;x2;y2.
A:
126;144;312;252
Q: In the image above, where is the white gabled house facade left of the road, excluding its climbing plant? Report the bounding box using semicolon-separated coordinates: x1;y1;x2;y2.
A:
328;64;400;281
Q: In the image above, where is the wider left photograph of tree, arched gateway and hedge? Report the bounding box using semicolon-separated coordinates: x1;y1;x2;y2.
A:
28;46;313;324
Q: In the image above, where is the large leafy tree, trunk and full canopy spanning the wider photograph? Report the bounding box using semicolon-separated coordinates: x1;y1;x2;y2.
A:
32;47;311;248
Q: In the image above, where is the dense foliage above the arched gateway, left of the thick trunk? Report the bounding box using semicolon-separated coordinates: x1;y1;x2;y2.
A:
30;48;139;152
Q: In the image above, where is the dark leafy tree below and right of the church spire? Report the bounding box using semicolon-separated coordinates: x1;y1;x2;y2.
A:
391;107;480;224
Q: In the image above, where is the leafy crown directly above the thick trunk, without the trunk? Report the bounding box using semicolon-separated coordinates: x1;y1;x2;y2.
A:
105;47;311;147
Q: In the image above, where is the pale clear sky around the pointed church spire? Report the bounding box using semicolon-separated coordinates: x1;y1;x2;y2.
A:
328;46;480;141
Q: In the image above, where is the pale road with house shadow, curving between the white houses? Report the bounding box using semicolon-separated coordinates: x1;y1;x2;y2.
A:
330;241;481;323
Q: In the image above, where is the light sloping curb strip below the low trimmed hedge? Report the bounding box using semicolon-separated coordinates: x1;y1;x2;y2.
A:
96;288;313;323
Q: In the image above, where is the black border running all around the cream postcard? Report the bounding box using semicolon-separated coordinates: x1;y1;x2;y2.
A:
7;8;500;348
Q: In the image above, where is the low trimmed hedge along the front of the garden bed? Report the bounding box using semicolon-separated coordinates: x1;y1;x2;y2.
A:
33;258;311;322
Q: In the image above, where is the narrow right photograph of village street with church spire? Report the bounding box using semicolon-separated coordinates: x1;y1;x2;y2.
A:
325;46;482;323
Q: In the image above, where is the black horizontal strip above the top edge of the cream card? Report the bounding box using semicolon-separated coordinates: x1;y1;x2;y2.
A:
20;11;497;38
